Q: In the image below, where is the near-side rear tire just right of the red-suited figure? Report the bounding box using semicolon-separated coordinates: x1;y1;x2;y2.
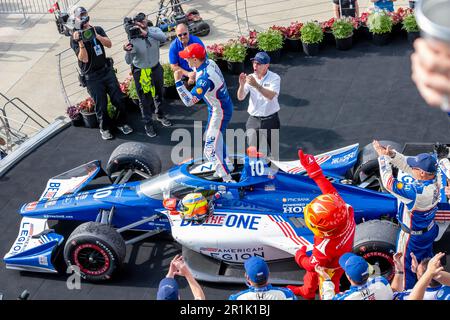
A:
353;220;399;281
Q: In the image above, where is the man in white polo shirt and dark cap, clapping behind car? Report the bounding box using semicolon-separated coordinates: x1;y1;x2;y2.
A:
237;52;280;152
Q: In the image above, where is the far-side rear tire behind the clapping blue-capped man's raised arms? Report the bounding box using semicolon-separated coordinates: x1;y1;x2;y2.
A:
352;140;403;191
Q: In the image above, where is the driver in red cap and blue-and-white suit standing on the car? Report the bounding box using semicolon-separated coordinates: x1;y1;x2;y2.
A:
174;43;233;182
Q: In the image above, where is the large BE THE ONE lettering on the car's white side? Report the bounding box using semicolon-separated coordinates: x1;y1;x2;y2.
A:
180;214;261;230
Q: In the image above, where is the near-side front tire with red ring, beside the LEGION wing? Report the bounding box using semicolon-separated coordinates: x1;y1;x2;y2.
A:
64;222;126;282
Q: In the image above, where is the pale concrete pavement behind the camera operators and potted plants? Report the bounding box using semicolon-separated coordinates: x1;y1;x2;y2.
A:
0;0;408;121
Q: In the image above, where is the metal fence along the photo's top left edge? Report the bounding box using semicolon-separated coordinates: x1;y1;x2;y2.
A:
0;0;79;16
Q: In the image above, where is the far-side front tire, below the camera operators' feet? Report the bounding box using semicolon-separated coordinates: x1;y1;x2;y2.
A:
106;142;161;180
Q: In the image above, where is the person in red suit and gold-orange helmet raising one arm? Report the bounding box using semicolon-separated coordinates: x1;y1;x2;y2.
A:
288;150;356;300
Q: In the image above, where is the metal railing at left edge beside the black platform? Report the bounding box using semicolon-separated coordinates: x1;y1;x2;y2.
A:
0;93;50;153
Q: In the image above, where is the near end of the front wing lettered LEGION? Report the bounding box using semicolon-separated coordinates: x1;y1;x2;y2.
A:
3;217;64;273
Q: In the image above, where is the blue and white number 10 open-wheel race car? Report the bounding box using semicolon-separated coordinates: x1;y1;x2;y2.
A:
4;142;450;284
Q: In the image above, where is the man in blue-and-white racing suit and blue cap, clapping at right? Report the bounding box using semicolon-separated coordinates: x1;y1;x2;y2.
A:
373;140;442;290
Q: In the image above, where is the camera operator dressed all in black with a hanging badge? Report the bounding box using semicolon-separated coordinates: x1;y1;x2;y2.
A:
70;7;133;140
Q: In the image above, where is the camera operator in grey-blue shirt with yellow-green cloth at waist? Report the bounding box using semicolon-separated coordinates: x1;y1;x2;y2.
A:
123;12;172;137
